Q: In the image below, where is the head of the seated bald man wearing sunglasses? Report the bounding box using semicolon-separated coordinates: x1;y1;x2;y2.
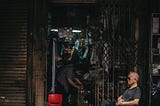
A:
127;72;139;86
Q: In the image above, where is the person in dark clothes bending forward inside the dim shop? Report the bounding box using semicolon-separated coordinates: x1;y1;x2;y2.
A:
56;64;83;106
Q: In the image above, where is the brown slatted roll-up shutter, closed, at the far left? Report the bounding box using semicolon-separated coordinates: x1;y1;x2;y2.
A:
0;0;28;106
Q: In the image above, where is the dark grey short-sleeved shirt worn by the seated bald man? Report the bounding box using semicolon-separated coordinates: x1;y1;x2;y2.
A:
122;87;141;101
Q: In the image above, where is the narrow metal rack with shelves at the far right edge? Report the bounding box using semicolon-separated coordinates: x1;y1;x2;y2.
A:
149;13;160;105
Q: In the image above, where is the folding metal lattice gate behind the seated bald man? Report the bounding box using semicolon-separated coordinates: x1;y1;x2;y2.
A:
95;0;137;106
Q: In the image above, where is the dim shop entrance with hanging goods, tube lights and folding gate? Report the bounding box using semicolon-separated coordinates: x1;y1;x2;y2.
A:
48;2;138;106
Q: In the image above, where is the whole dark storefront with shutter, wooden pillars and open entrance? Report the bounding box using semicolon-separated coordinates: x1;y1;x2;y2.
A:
0;0;160;106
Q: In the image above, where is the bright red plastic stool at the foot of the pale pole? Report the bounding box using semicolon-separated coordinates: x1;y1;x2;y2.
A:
48;94;62;106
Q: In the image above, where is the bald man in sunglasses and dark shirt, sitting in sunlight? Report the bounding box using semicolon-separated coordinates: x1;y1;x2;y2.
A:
117;72;141;106
